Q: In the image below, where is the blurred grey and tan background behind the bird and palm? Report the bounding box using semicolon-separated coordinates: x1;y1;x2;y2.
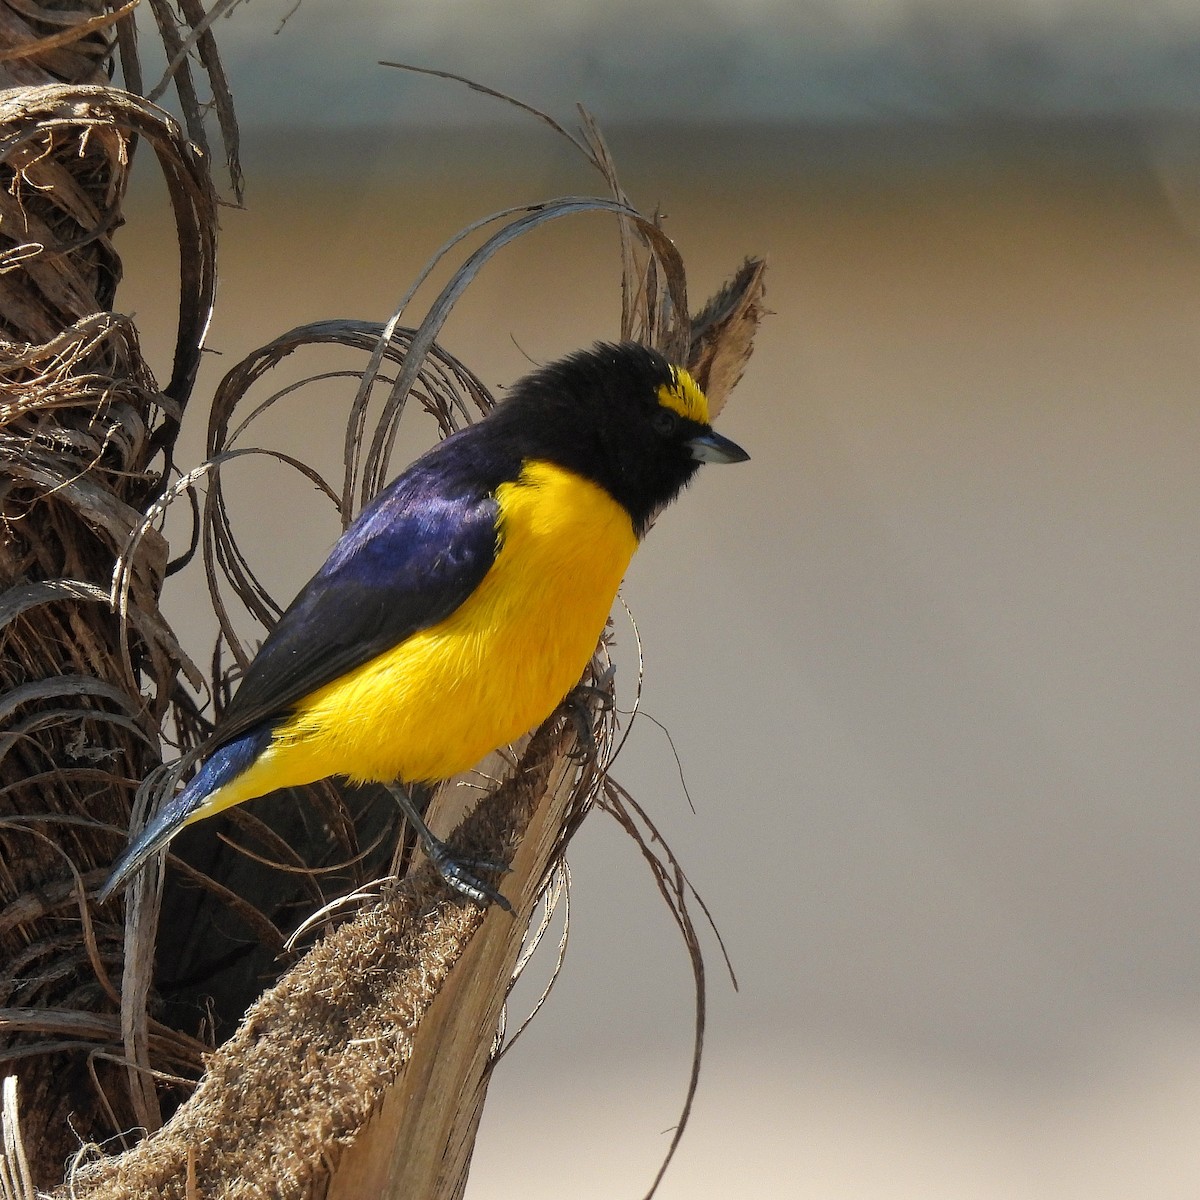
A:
118;0;1200;1200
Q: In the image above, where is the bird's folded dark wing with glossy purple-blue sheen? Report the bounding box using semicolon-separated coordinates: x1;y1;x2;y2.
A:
210;463;498;744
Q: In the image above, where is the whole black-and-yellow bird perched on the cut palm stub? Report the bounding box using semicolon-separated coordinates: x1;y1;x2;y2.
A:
100;343;749;907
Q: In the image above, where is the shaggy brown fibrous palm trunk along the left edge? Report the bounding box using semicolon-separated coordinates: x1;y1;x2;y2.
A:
0;14;215;1183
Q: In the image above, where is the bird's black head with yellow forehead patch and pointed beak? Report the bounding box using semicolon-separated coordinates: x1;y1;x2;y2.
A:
496;342;750;536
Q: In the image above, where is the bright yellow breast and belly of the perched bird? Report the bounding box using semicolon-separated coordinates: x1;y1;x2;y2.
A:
193;453;637;820
